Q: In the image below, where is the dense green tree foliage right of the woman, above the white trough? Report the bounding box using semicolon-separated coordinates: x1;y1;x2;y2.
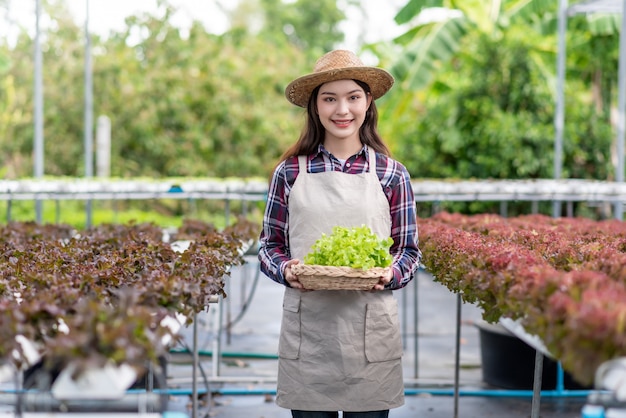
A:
372;0;618;186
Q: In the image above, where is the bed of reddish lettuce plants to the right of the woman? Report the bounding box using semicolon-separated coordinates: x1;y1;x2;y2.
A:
418;213;626;385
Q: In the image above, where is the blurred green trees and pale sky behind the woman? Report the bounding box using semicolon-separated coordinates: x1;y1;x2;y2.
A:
0;0;621;225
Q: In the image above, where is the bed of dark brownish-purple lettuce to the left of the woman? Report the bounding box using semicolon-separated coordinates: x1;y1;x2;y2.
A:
0;219;258;398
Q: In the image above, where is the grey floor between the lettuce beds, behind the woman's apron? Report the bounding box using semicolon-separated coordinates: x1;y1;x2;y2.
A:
168;258;586;418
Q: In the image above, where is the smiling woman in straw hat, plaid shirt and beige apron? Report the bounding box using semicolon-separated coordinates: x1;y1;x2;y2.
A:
259;50;421;418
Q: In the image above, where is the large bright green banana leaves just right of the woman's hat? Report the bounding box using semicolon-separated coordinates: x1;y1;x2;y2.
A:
369;0;556;131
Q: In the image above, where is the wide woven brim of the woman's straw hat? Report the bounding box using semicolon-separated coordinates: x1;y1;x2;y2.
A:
285;67;394;107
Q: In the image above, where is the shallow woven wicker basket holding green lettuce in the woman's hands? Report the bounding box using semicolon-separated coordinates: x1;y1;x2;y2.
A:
291;264;389;290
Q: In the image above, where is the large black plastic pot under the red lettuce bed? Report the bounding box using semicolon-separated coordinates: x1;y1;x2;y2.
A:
476;322;591;390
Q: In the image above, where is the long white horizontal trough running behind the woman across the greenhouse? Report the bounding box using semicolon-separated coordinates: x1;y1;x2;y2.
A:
0;178;626;203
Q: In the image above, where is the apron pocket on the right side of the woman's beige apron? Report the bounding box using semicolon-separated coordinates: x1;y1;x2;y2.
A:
365;300;402;363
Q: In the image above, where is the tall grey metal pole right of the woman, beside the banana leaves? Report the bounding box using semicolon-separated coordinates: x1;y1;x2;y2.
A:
552;0;567;218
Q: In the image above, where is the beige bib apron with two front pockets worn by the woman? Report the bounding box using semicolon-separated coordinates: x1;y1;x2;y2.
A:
276;150;404;412
